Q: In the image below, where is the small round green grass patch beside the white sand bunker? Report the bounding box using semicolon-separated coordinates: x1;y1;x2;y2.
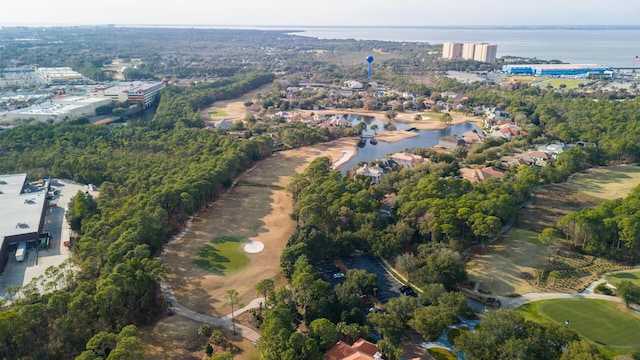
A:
194;236;249;275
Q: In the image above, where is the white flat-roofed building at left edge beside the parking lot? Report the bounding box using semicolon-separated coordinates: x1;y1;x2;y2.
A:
0;174;49;270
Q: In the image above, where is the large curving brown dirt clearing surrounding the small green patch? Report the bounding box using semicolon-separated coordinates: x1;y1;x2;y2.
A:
164;139;357;316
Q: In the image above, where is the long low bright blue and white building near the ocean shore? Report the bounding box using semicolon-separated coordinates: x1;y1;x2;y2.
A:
502;64;614;77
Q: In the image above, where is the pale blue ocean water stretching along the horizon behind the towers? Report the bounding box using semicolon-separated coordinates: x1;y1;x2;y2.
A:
282;26;640;68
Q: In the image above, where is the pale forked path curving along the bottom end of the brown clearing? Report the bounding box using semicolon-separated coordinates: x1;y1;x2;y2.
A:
160;280;264;344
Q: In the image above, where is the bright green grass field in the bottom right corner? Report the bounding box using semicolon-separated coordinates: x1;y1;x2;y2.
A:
518;299;640;352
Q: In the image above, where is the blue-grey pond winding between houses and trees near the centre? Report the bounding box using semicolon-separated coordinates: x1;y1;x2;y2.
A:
340;115;481;174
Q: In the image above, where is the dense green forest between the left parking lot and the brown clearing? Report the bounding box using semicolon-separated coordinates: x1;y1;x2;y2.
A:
0;75;272;359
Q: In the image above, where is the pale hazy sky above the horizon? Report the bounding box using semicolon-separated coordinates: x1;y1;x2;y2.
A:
0;0;640;26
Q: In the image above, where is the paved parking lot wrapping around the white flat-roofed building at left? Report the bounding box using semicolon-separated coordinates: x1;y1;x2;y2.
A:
0;179;88;297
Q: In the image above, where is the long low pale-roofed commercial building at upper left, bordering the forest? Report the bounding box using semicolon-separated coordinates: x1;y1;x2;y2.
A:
7;96;111;123
